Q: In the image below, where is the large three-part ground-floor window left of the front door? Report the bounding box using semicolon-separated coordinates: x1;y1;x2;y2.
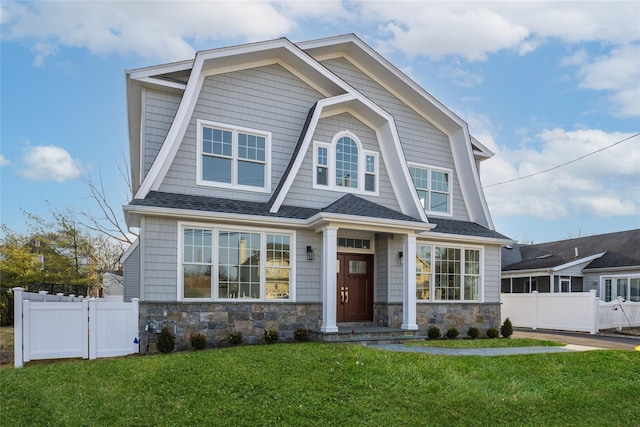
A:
179;226;295;301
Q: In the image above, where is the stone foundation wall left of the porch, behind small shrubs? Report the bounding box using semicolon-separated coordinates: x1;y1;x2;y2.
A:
140;302;322;353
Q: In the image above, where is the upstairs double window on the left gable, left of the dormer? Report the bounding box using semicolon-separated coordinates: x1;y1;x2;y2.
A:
197;120;271;191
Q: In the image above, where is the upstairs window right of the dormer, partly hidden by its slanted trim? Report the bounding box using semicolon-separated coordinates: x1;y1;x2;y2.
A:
409;164;451;214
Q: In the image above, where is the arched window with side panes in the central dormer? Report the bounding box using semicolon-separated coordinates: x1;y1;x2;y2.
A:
313;132;378;194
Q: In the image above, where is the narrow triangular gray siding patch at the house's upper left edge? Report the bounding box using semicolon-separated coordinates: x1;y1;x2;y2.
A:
142;89;182;176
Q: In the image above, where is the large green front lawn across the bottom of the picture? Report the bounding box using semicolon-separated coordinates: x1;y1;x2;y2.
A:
0;343;640;426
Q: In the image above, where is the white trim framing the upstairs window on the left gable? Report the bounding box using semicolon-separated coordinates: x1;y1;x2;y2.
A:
196;119;271;193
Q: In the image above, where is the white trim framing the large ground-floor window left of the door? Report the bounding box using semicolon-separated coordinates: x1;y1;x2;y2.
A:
176;222;297;303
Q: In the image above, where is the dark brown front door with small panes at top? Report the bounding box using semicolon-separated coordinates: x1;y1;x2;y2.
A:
336;254;373;322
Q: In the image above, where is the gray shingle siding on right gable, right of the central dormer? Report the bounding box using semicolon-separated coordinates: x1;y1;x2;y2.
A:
322;58;469;221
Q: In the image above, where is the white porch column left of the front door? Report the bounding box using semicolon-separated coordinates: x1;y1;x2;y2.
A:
320;227;338;332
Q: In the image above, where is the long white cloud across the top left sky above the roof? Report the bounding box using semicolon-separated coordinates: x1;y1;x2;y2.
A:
2;1;294;64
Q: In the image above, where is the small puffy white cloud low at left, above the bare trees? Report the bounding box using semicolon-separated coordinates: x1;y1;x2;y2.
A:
20;145;80;182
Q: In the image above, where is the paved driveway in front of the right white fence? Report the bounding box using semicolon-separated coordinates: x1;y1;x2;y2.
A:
512;328;640;350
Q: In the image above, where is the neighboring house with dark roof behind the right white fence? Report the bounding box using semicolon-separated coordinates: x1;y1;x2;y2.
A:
502;229;640;302
